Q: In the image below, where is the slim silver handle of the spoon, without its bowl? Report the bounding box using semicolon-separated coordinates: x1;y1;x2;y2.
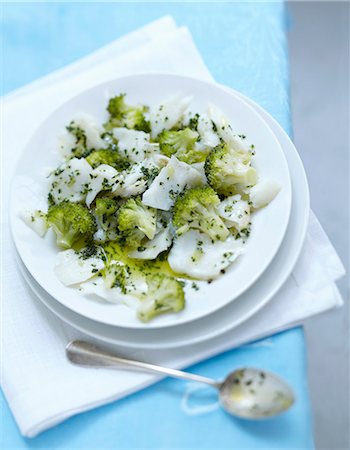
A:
66;341;221;388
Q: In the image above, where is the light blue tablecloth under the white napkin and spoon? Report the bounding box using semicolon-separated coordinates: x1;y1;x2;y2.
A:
1;2;313;450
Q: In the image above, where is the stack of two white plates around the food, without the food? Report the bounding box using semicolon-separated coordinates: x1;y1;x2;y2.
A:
11;75;310;348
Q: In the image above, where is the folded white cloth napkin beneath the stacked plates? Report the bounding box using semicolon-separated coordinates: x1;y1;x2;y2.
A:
1;17;344;437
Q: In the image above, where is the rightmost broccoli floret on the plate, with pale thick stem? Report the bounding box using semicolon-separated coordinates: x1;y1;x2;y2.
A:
204;144;257;196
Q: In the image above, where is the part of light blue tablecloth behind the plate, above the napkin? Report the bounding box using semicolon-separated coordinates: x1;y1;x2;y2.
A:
1;1;290;132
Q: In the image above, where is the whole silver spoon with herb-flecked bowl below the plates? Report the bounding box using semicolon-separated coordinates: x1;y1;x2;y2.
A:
66;341;294;419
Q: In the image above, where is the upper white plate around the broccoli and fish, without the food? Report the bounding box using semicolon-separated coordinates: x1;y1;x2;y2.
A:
11;75;291;329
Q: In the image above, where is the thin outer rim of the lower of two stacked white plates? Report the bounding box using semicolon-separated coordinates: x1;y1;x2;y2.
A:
13;93;310;350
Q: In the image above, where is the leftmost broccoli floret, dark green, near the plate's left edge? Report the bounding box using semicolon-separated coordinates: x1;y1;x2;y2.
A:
47;200;96;249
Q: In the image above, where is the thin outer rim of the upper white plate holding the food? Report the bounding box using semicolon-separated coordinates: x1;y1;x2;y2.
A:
10;74;293;331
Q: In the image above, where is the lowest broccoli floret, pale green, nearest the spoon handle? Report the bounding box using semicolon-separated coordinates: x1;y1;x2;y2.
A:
137;274;185;322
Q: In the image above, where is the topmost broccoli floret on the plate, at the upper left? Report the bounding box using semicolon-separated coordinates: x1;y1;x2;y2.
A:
104;94;151;133
